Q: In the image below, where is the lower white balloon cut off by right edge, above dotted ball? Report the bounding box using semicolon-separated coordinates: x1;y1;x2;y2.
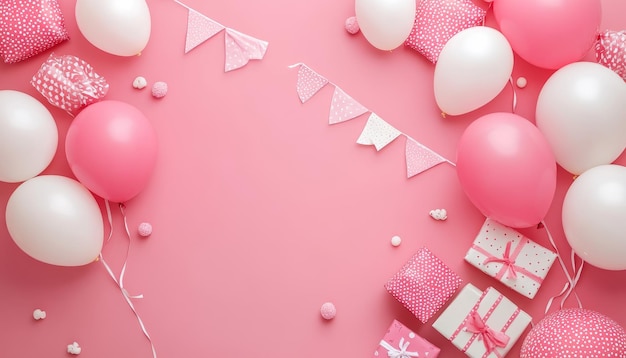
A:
562;164;626;270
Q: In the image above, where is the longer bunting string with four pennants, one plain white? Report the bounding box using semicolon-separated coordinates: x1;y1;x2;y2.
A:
289;63;456;178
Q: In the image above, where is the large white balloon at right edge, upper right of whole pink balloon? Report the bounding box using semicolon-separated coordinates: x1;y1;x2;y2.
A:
536;62;626;174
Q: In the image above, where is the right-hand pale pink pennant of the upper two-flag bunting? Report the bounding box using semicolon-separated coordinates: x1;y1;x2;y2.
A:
224;28;268;72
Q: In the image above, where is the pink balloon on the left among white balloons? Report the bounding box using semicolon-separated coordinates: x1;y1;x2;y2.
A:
65;100;157;203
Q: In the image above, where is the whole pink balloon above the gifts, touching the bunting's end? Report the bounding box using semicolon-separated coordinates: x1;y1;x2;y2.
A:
457;113;556;228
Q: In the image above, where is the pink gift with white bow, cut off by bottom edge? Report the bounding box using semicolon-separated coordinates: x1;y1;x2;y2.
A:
374;320;439;358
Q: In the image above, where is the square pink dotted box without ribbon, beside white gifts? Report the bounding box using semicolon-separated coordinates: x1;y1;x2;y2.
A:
385;247;462;323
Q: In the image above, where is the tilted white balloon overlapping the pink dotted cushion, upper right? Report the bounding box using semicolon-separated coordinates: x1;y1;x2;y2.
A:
434;26;513;115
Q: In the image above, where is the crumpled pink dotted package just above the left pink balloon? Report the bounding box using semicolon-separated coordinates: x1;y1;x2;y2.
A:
30;54;109;115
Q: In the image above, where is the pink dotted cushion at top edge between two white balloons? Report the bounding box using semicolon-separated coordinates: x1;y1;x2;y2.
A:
405;0;487;63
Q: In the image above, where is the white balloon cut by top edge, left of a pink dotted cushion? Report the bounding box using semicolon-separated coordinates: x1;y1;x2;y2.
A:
355;0;417;51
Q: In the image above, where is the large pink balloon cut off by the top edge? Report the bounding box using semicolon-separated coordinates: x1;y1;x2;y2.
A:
493;0;602;69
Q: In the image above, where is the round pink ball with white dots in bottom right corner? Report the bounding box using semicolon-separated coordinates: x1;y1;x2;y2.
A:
520;308;626;358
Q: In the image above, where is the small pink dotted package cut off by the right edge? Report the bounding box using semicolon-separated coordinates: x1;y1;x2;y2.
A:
595;30;626;80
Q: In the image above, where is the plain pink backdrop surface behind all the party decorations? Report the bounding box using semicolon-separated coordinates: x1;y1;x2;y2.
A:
0;0;626;358
